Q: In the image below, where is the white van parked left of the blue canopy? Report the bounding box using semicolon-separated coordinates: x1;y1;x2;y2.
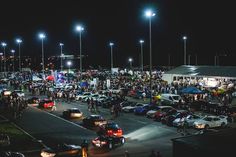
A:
161;93;182;106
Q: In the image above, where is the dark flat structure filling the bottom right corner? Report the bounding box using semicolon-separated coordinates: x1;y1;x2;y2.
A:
172;128;236;157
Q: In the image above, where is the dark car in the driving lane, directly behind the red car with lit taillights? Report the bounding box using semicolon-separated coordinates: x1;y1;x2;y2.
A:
83;115;107;127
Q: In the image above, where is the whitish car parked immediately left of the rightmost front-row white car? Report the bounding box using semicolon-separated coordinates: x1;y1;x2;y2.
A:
173;114;202;127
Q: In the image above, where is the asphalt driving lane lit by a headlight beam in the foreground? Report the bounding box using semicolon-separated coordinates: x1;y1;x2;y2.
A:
9;92;234;157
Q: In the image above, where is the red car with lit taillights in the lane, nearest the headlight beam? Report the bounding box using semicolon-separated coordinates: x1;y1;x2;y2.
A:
97;122;123;137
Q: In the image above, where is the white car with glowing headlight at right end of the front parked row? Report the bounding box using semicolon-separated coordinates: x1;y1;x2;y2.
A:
193;116;228;129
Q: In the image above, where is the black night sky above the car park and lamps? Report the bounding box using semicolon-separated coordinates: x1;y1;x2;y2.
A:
0;0;236;67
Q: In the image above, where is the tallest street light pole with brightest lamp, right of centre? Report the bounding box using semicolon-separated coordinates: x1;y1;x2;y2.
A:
145;10;156;104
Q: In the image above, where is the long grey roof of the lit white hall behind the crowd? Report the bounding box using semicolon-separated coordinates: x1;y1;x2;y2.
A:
165;65;236;78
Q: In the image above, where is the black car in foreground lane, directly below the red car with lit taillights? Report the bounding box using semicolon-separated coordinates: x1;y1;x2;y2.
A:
92;136;125;149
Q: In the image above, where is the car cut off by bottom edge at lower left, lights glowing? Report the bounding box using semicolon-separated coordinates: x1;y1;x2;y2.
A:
40;143;82;157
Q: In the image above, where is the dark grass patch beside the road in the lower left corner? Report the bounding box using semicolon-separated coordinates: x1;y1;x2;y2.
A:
0;122;42;152
